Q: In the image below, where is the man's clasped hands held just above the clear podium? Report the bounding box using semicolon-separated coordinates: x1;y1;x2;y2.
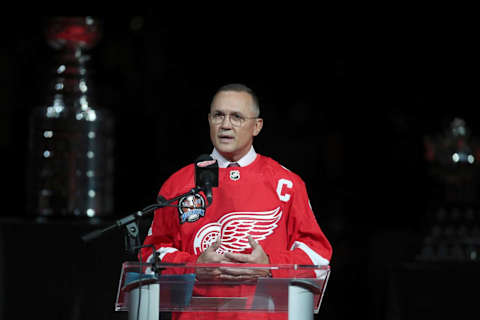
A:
197;236;270;280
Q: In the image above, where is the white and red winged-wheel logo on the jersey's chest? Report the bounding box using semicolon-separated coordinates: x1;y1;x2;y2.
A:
193;207;282;254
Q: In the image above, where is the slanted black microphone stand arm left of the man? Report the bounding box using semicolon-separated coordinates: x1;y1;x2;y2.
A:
82;187;203;255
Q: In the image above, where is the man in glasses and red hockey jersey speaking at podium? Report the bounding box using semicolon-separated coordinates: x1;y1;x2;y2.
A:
142;84;332;319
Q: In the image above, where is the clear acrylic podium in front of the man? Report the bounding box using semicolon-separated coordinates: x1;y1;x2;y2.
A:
115;262;330;320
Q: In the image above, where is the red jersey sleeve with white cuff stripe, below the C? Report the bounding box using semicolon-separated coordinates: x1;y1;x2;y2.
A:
263;176;332;276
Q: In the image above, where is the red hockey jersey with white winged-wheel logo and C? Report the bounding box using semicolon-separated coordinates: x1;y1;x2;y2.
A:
141;154;332;320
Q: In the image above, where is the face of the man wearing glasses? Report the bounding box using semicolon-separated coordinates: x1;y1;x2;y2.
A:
208;91;263;161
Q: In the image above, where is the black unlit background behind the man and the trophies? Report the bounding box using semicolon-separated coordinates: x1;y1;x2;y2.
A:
0;14;480;319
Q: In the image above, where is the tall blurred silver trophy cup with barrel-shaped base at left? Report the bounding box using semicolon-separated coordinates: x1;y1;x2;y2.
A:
27;17;114;218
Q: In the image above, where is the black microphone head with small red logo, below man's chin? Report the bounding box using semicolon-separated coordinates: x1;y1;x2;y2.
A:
195;154;218;205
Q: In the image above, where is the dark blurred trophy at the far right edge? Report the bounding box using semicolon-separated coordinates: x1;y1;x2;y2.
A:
417;118;480;262
